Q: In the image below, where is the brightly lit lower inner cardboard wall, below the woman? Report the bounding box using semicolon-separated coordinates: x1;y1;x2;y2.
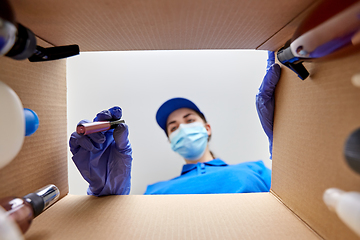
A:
26;193;319;240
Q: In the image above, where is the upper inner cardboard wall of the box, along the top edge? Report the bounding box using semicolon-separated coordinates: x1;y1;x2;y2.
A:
11;0;318;51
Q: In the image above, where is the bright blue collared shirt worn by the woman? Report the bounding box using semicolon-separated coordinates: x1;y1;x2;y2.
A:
145;159;271;194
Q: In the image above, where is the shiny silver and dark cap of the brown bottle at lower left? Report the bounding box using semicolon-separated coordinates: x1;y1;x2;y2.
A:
24;184;60;217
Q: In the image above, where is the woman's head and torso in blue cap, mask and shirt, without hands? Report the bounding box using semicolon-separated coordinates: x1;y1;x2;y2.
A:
145;98;271;194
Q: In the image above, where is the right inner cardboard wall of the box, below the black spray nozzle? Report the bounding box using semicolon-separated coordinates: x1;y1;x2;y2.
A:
272;50;360;239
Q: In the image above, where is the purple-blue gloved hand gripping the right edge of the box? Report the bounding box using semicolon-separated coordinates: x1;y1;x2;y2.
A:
256;51;281;159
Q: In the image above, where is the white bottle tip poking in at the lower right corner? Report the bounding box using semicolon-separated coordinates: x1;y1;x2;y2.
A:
323;188;360;237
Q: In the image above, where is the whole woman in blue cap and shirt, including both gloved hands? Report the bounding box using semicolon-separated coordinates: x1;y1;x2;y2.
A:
69;52;280;196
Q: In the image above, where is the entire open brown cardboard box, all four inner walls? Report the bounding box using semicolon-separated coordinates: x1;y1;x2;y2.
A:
0;0;360;240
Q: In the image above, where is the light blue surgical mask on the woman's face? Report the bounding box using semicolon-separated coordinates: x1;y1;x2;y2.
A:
169;122;209;160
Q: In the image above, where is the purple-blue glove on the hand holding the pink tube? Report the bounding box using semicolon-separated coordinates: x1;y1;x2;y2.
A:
69;107;132;196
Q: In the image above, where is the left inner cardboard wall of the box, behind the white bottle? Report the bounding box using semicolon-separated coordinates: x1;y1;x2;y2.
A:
0;39;68;201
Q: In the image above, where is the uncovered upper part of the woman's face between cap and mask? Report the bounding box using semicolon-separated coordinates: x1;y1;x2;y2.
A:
166;108;211;136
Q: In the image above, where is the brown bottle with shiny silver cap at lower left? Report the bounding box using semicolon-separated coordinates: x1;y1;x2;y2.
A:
0;184;60;233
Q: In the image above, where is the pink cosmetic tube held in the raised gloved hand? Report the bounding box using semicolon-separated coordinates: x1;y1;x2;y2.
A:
76;120;125;135
